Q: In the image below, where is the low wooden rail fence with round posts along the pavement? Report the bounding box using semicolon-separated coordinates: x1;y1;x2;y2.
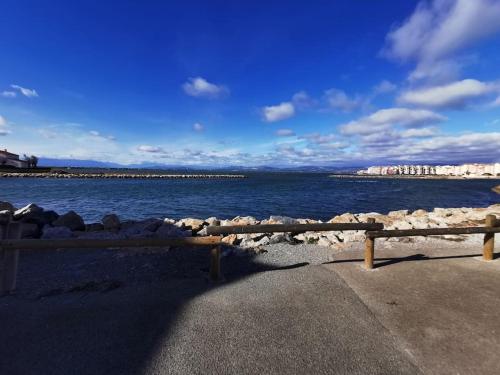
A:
0;215;500;294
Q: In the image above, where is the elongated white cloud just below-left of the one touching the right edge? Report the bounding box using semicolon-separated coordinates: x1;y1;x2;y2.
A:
340;108;446;135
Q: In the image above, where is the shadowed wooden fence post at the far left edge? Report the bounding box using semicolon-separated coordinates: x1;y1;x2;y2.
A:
0;223;21;295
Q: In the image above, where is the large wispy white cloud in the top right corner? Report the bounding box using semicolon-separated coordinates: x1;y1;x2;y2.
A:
382;0;500;79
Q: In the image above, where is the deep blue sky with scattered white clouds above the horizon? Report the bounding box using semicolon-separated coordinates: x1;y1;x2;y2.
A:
0;0;500;166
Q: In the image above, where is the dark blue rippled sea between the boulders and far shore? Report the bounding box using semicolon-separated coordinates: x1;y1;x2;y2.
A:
0;173;500;222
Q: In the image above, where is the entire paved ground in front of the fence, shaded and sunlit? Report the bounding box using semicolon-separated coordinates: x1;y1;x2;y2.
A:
0;239;500;374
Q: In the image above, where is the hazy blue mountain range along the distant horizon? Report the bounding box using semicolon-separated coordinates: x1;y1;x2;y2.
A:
38;158;366;173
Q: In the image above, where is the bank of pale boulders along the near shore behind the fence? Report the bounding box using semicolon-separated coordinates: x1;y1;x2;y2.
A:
0;202;500;254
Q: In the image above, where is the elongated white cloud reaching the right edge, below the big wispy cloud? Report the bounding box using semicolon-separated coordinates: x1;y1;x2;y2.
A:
398;79;499;108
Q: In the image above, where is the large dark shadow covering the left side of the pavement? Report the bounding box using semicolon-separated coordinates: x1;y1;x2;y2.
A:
0;249;308;374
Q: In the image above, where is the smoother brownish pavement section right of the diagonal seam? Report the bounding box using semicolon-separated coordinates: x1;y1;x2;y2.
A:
327;241;500;374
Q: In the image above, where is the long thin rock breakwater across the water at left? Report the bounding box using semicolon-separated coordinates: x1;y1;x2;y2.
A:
0;172;246;179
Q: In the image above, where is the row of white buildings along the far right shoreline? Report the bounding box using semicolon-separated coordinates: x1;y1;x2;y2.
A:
357;163;500;177
